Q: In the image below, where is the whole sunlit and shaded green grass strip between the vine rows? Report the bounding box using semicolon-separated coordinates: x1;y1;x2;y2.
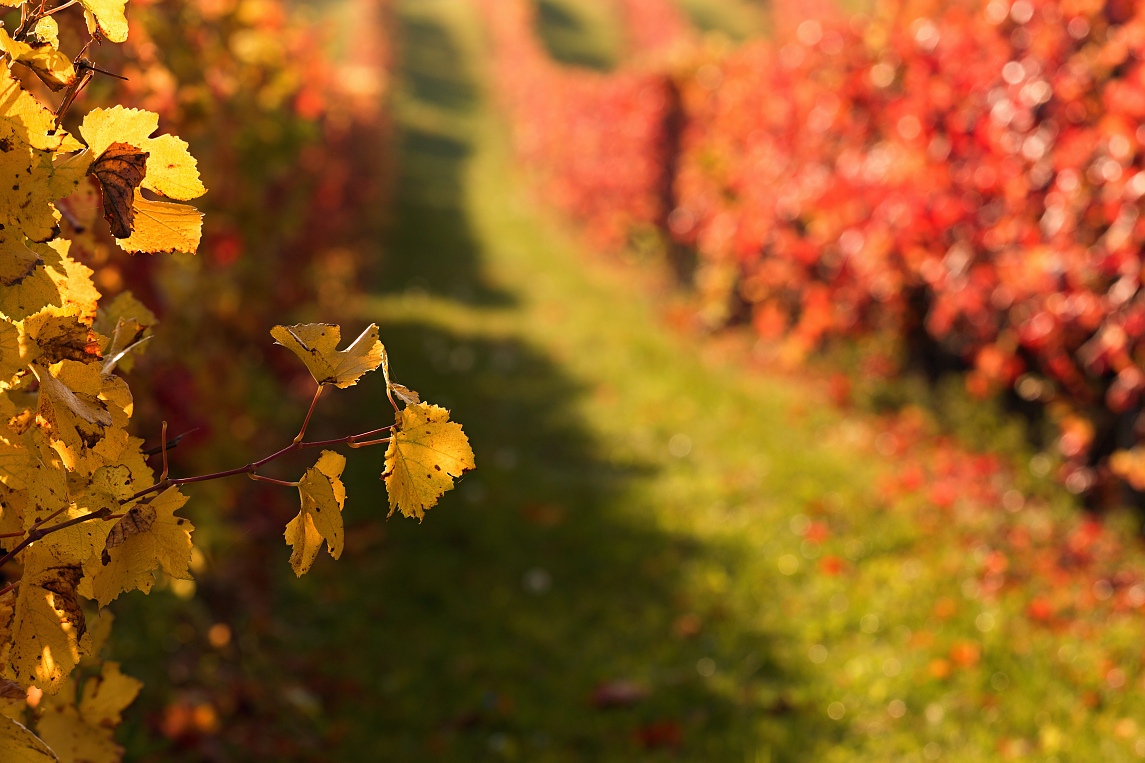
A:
111;0;1145;763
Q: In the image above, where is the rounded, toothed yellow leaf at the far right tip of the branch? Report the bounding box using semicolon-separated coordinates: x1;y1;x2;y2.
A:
381;403;476;520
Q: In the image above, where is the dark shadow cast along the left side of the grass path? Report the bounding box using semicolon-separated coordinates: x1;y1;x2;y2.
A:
111;0;842;763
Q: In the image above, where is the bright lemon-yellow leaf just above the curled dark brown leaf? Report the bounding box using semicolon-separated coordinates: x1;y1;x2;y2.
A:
79;105;207;201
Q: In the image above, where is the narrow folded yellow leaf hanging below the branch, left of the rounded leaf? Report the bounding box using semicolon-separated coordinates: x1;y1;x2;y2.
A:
286;450;346;577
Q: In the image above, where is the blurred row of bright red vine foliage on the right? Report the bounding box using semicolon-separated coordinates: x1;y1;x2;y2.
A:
487;0;1145;493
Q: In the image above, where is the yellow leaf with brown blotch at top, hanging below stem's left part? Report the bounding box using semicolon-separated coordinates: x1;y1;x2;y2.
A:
80;487;195;606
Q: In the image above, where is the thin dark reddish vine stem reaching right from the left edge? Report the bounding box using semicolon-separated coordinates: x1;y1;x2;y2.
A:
0;385;394;570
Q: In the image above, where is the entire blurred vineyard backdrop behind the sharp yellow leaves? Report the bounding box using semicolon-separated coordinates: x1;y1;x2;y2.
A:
62;0;1145;763
